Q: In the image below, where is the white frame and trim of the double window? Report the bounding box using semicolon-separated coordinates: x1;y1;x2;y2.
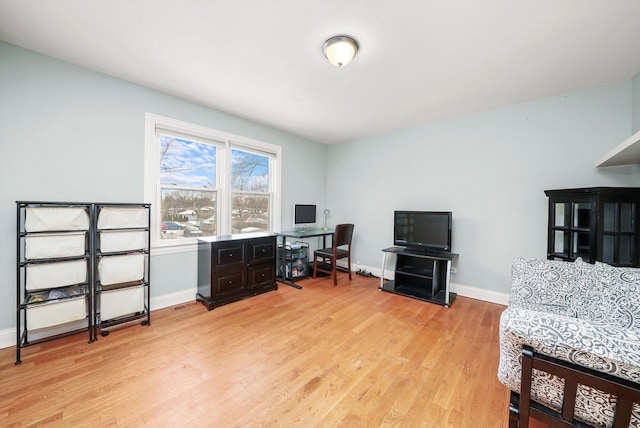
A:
149;113;282;254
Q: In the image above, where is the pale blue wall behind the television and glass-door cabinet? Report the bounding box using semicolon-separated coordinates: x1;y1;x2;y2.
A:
327;81;636;292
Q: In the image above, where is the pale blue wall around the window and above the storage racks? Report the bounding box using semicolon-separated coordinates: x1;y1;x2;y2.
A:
0;42;327;331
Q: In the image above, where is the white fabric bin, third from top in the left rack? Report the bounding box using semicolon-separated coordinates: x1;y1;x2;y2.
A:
25;260;87;290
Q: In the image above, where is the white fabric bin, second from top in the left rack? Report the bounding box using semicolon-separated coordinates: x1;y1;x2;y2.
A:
24;233;87;260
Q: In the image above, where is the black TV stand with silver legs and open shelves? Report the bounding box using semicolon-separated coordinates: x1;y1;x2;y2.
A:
380;247;458;307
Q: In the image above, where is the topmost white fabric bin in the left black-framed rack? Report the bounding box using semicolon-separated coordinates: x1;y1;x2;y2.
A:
24;208;89;232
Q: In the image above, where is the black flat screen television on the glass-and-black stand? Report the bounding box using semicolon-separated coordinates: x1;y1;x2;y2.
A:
393;211;453;251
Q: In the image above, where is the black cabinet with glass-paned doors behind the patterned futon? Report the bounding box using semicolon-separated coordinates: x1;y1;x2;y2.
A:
545;187;640;267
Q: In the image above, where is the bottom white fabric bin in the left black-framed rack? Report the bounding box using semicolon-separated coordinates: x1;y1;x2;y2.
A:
27;297;88;330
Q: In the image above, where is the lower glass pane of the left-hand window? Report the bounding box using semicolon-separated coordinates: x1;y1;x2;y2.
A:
160;188;218;239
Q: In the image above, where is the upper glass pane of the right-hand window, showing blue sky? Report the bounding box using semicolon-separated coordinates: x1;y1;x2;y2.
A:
231;149;269;192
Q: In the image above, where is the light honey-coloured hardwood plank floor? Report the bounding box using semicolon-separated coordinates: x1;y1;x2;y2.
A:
0;275;508;428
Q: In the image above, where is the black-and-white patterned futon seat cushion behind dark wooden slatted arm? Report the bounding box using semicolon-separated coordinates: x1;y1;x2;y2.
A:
498;307;640;426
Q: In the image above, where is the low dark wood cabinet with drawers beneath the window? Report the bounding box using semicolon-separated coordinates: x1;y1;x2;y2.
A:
196;234;278;310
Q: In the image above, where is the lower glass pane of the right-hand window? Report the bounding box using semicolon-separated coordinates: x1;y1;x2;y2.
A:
231;193;270;233
